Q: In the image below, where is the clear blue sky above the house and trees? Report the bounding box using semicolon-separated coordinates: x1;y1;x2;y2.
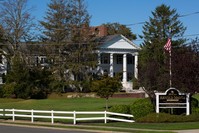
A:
28;0;199;44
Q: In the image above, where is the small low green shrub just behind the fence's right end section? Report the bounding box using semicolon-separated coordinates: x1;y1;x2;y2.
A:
109;105;130;114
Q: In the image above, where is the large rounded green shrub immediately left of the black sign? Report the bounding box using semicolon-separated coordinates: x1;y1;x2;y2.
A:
130;98;154;119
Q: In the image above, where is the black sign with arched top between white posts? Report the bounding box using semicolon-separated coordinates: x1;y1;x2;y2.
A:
155;88;190;115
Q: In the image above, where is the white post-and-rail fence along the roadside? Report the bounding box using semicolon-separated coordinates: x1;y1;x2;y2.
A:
0;109;135;125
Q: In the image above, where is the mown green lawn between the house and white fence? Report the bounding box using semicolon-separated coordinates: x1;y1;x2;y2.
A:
0;98;136;111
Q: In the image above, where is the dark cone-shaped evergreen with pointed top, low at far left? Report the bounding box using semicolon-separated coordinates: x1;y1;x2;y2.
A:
3;53;30;99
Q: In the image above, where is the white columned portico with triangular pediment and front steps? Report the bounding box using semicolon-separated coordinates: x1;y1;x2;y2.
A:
96;35;140;92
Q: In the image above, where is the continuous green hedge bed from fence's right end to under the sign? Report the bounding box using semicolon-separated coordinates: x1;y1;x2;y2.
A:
110;98;199;123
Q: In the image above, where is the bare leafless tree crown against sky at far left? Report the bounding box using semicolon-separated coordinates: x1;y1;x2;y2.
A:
0;0;35;51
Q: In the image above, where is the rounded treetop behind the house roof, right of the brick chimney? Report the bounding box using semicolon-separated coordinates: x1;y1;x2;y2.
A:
104;23;137;40
